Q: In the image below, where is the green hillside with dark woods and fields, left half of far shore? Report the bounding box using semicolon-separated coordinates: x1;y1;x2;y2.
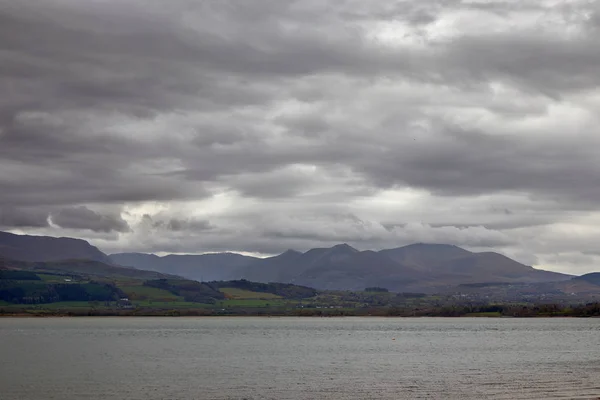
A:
0;260;318;315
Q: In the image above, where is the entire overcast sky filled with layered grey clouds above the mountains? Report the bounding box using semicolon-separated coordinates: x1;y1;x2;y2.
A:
0;0;600;274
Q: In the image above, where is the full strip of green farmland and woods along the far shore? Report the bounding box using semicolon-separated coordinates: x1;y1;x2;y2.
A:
0;269;600;317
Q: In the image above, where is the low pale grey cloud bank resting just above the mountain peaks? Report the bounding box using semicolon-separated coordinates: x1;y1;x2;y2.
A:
99;212;516;254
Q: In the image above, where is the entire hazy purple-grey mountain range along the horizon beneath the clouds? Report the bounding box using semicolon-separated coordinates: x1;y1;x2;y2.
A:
0;232;572;292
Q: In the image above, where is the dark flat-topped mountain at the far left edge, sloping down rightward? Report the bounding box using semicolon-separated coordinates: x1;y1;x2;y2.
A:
0;232;111;264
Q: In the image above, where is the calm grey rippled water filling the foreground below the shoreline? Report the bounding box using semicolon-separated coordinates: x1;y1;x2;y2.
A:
0;317;600;400
